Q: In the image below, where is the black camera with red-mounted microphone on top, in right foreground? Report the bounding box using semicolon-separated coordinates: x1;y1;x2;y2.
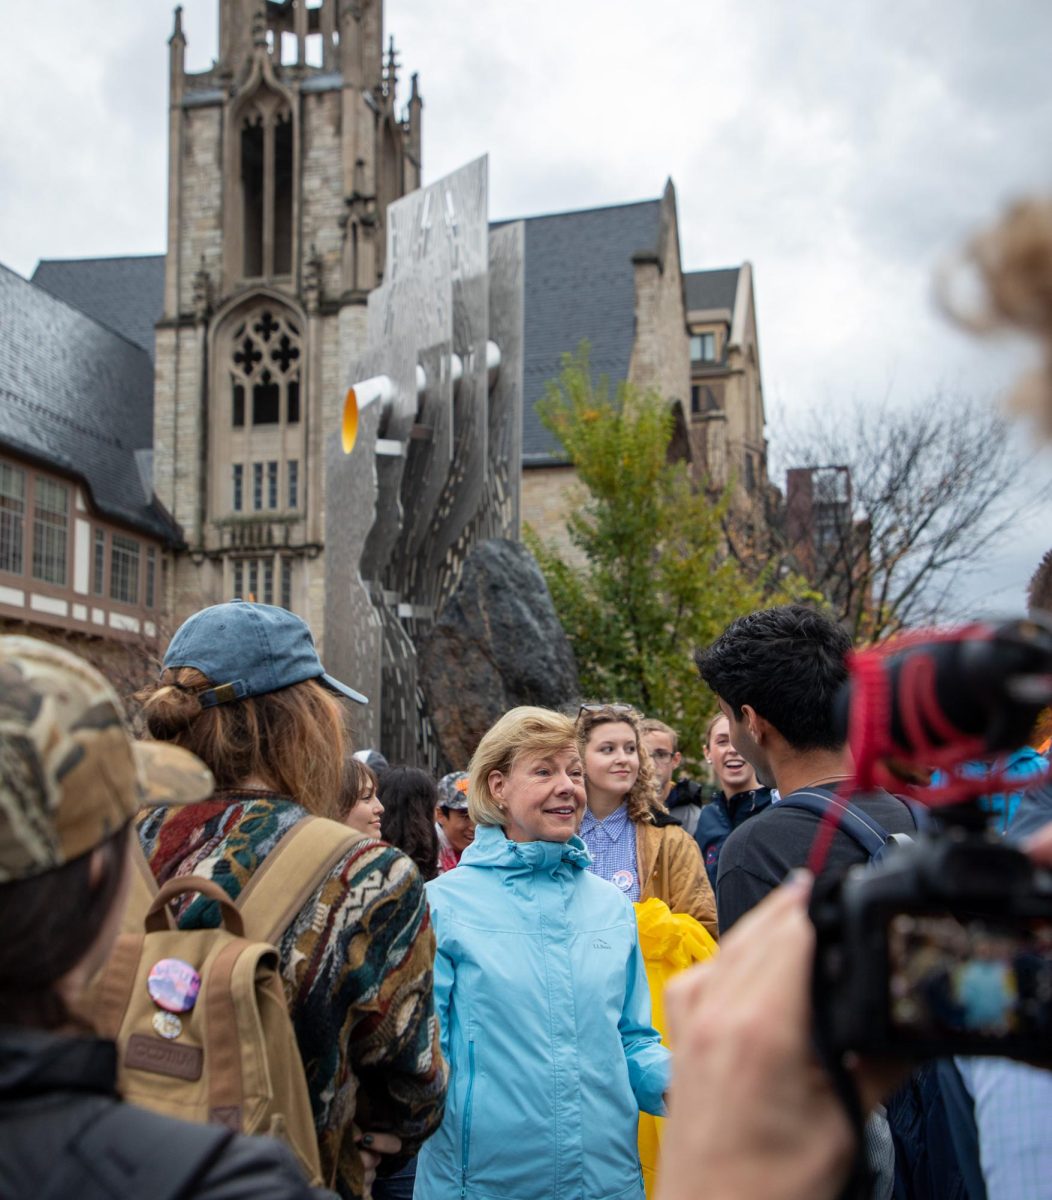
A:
812;619;1052;1061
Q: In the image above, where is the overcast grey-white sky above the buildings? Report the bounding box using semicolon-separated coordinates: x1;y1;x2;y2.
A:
0;0;1052;610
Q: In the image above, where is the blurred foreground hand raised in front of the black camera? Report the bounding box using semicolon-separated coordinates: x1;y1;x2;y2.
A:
657;873;858;1200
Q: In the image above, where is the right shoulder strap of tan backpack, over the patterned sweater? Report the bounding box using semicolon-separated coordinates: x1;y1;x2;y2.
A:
238;817;366;944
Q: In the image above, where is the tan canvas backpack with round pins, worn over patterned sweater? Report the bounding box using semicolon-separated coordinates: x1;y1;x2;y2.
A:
89;817;363;1186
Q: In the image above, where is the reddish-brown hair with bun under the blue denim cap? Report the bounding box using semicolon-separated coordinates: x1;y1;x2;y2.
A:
136;667;348;820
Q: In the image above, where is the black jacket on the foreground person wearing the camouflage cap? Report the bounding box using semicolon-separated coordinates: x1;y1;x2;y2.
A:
0;1026;331;1200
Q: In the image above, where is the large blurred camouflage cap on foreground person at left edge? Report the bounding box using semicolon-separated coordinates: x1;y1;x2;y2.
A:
0;637;215;883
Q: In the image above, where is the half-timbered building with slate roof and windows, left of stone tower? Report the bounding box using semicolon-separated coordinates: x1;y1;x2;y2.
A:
0;268;172;659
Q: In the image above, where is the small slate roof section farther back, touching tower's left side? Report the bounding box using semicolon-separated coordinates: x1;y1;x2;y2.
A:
32;254;164;359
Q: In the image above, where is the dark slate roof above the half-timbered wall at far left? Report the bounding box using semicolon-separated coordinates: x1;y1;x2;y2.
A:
0;266;179;541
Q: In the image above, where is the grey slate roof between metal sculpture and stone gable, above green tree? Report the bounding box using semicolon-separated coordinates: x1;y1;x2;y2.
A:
503;200;661;467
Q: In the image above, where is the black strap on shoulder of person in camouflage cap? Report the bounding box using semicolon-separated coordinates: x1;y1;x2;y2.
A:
38;1103;233;1200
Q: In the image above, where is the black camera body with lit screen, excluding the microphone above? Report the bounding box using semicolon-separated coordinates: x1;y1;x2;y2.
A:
812;829;1052;1061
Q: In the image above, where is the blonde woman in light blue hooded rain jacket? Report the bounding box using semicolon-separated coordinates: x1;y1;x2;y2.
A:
414;708;668;1200
